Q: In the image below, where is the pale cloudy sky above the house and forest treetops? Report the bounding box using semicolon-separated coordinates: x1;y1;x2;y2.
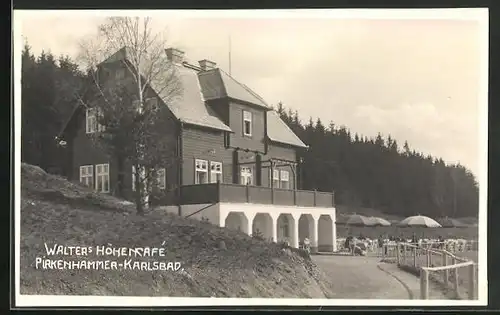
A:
15;11;487;178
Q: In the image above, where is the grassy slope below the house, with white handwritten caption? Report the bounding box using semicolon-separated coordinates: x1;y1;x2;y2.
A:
21;164;333;298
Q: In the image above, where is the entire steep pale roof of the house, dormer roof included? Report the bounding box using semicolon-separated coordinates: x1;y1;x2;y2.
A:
64;49;307;148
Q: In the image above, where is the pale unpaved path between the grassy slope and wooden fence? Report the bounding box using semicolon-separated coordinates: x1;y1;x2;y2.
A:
313;255;450;300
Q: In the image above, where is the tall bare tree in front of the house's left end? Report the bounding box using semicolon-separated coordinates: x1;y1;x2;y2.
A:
79;17;182;214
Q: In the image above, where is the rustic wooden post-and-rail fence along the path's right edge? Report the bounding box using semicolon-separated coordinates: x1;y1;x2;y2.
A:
382;243;477;300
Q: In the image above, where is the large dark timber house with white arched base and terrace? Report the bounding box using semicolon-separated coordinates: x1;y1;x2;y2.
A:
62;48;336;251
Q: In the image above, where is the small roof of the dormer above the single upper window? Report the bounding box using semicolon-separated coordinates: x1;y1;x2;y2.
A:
198;69;270;109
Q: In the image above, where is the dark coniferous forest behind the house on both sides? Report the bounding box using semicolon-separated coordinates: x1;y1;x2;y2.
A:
21;45;479;217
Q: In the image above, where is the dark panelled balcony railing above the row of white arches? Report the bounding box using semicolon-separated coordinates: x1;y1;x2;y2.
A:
167;183;335;208
